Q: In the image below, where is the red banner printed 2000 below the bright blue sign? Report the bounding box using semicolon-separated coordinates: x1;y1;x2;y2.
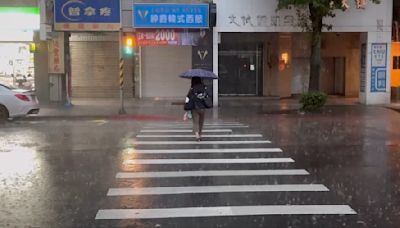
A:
136;29;207;46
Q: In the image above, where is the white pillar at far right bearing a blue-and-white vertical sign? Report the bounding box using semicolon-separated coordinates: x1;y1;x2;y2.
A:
360;31;391;105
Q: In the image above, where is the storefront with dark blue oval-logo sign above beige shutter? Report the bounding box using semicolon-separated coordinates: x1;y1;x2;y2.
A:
48;0;126;100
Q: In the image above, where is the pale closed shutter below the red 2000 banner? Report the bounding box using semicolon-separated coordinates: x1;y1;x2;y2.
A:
142;46;192;98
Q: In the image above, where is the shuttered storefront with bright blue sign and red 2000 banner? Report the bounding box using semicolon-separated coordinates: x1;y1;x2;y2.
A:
132;3;213;98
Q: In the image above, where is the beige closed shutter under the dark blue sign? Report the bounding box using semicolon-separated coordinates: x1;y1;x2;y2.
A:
71;41;133;98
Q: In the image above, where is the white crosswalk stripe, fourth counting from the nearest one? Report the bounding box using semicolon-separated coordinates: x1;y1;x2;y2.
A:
124;158;294;165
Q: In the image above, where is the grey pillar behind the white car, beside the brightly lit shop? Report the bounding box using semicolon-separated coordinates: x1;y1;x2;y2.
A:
33;32;50;104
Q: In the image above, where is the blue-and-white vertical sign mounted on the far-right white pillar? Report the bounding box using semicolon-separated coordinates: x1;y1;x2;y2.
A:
371;43;387;92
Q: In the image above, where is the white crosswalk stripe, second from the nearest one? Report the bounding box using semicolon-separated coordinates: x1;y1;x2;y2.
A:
107;184;329;196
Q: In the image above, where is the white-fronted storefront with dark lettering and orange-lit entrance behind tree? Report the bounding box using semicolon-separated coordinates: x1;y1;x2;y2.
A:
214;0;392;104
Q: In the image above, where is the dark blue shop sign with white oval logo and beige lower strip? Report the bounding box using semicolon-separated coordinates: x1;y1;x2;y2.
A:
54;0;121;31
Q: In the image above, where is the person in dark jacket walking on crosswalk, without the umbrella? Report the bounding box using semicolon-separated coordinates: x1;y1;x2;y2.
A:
187;77;210;141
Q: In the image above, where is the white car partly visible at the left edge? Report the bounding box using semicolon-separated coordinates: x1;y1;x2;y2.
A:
0;84;40;120
